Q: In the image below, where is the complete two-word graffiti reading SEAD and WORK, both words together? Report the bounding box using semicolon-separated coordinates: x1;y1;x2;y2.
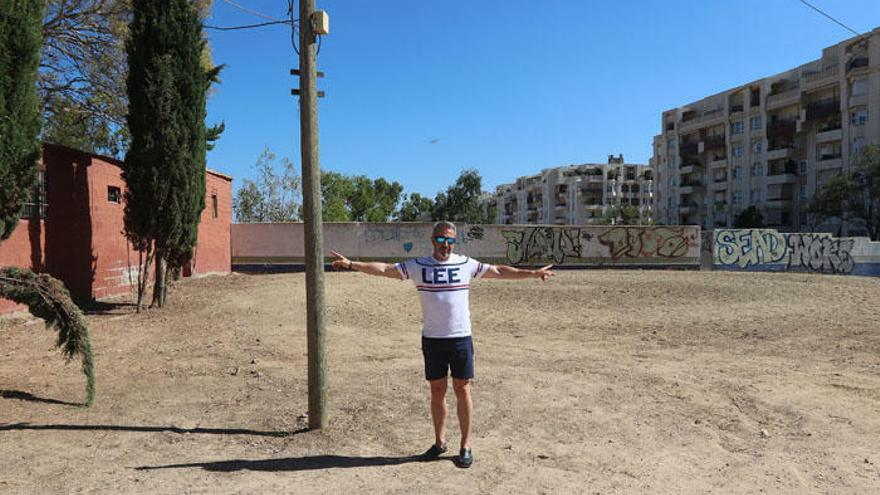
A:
715;229;855;274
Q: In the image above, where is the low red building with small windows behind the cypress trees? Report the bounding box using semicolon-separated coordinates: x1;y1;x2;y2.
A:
0;144;232;314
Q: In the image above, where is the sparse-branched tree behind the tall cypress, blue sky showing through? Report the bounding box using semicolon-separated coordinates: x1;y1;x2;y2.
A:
38;0;213;156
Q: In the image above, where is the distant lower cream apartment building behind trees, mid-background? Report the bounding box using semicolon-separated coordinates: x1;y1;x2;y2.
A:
490;155;654;225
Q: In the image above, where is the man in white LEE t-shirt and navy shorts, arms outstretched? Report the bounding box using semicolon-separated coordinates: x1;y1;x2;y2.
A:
331;222;556;468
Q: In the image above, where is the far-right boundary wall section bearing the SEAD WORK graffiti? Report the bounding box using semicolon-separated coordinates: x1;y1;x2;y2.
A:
703;229;880;277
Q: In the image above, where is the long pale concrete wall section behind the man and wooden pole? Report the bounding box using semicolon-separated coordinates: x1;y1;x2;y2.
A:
232;223;700;271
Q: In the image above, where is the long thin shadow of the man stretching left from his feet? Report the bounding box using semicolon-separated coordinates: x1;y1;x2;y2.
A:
135;455;440;473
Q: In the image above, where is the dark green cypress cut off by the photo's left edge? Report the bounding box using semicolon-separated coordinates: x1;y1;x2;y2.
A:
0;0;44;241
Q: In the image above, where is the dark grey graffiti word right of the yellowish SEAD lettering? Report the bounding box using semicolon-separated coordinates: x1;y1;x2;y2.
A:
788;234;855;274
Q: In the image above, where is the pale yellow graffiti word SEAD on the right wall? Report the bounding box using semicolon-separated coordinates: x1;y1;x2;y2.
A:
715;229;786;268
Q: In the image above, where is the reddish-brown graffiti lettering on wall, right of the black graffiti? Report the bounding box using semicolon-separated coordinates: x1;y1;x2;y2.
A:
599;227;696;261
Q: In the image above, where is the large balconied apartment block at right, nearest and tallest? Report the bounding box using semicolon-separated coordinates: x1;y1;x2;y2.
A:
651;28;880;231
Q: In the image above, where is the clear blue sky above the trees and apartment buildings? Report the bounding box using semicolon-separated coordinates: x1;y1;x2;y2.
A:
206;0;880;197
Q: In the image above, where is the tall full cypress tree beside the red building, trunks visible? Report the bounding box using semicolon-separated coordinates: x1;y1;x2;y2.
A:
123;0;219;307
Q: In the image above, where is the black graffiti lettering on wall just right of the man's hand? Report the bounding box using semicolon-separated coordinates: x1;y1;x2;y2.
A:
501;227;581;264
